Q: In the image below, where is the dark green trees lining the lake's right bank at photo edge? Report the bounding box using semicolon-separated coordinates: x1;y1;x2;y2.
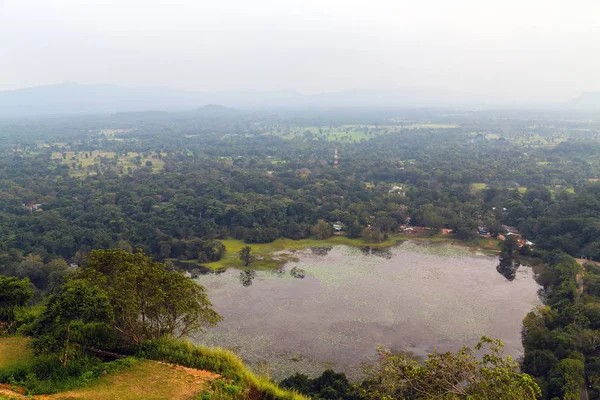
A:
522;251;600;399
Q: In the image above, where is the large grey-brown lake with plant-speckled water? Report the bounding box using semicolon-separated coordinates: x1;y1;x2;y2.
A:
195;242;539;379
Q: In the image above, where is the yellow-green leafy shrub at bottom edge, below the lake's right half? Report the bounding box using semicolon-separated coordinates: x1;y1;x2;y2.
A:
362;337;542;400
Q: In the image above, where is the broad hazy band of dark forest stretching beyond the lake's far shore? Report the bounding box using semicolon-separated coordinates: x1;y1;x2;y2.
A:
0;113;600;266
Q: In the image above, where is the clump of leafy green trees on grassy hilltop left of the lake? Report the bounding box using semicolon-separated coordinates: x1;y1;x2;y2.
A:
25;249;221;364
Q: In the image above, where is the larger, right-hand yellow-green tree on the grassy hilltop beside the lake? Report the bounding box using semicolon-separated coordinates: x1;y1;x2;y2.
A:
76;249;222;345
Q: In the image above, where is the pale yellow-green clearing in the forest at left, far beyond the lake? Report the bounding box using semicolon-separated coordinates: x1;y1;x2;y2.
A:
52;150;165;177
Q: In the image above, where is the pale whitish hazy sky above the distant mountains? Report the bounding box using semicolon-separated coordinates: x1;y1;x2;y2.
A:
0;0;600;101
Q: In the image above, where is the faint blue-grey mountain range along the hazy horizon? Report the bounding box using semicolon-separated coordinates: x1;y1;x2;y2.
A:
0;83;600;118
